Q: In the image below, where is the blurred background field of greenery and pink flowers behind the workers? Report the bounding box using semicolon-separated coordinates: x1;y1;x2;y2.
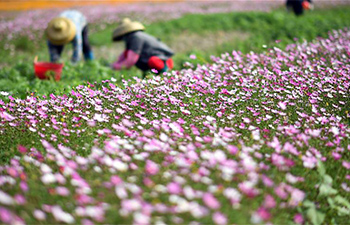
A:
0;0;350;97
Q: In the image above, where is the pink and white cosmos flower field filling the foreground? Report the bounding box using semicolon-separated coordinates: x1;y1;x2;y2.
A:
0;16;350;224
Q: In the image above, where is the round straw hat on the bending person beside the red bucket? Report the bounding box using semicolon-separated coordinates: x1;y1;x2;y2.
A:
46;17;76;45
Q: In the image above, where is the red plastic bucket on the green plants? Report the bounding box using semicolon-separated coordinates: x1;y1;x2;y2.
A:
34;62;63;81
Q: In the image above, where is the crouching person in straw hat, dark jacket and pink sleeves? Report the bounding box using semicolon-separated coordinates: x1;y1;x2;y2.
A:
111;18;174;76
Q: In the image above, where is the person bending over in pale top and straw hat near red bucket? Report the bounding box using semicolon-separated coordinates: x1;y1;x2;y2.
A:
46;10;94;63
